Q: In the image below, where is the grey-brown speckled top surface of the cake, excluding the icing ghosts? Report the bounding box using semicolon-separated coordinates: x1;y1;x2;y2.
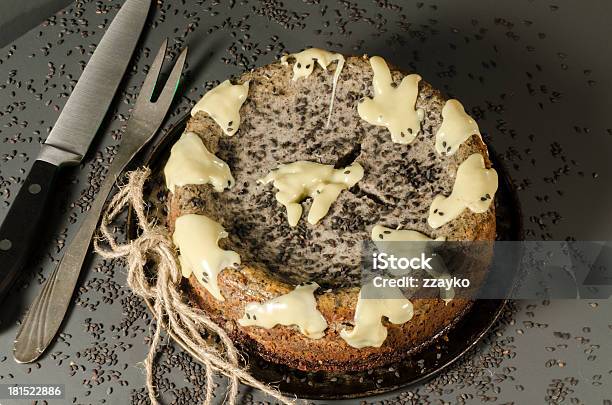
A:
169;52;498;287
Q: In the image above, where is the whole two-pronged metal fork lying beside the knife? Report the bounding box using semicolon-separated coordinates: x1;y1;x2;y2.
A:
14;39;187;363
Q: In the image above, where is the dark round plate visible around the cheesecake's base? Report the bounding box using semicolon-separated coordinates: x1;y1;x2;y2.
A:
128;116;523;400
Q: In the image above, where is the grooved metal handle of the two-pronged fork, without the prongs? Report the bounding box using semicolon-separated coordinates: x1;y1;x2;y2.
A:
14;153;130;363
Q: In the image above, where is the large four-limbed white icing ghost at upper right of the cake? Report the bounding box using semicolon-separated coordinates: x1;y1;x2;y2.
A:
357;56;424;144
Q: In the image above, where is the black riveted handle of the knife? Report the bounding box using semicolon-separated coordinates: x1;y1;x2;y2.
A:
0;160;59;302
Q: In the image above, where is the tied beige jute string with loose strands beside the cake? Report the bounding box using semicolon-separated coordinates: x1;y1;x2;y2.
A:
94;168;295;405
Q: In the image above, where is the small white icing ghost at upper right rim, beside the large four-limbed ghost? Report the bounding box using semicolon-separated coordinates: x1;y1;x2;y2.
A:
436;100;481;155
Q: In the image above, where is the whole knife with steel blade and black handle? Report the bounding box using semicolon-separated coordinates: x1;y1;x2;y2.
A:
0;0;151;302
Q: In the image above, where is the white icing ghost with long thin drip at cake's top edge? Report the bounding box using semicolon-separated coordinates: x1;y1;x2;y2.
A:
281;48;344;127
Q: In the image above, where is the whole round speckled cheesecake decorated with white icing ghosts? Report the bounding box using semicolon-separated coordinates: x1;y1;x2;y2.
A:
166;51;497;371
